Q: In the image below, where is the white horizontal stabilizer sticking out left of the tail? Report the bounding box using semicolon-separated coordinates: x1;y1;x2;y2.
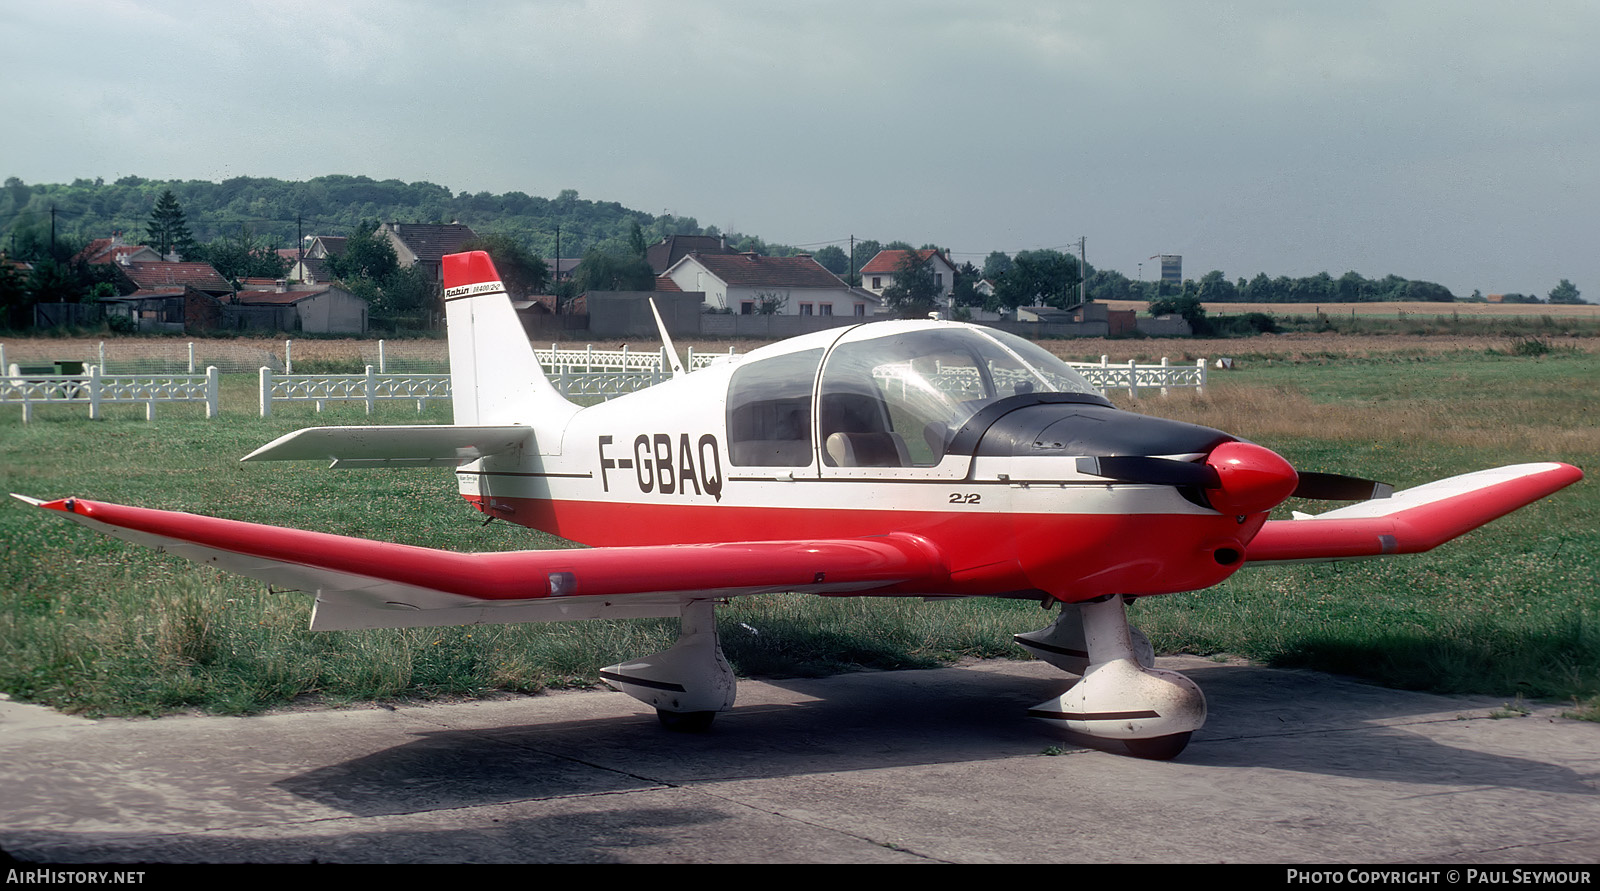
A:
242;424;533;467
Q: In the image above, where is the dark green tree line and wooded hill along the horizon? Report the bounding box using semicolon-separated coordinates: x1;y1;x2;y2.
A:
0;174;1581;325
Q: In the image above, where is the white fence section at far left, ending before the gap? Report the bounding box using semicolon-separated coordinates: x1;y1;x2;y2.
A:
0;365;221;424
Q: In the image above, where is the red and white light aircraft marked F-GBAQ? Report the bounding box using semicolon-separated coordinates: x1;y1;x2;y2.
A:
19;253;1582;758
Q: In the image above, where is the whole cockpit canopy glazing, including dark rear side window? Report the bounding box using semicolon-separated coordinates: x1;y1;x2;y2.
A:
728;323;1099;467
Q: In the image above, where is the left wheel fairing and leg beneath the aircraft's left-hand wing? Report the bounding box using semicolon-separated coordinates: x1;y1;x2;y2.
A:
600;600;734;733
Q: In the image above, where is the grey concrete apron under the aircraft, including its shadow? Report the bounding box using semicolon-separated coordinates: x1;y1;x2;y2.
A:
0;657;1600;863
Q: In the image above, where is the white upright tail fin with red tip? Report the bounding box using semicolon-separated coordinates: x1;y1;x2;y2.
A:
445;251;578;429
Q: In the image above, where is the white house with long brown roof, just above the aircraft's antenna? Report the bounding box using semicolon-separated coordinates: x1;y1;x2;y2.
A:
664;251;883;317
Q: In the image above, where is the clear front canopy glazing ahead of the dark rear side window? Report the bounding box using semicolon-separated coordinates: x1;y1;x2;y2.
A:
818;326;1098;467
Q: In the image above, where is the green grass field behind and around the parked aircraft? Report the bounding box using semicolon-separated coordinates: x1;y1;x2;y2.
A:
0;339;1600;713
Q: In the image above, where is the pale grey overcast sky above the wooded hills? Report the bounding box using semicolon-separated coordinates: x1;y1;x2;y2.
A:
0;0;1600;302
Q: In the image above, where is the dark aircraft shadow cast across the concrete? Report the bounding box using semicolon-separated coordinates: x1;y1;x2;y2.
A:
278;665;1595;814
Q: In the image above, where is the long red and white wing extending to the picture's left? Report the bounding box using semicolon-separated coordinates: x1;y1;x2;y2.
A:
14;496;947;630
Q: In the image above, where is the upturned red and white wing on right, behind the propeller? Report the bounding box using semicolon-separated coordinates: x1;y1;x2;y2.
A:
1245;462;1584;563
